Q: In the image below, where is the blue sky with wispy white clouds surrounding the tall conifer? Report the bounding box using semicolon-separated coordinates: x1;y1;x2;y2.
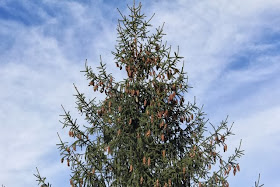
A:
0;0;280;187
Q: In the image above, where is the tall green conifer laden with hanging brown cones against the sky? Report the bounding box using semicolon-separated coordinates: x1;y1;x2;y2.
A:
36;1;252;187
